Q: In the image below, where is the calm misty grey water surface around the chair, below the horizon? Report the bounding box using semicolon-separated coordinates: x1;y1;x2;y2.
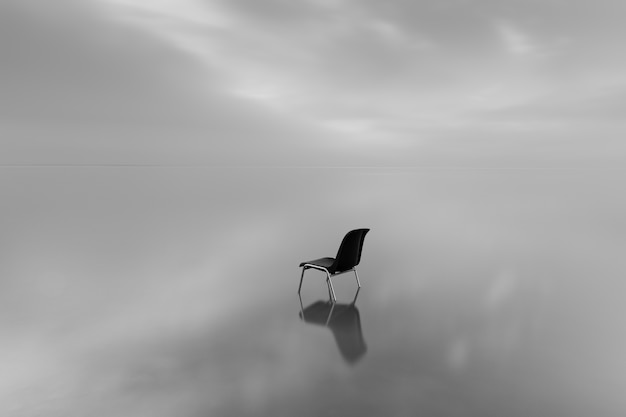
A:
0;167;626;417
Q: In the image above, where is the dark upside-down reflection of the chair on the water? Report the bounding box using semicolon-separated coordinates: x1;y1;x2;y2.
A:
300;290;367;364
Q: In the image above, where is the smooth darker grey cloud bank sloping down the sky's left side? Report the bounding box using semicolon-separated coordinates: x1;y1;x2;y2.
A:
0;0;346;164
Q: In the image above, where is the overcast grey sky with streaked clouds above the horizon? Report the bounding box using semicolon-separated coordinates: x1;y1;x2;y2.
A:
0;0;626;167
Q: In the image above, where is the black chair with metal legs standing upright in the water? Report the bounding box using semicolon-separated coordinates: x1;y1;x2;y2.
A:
298;229;370;302
